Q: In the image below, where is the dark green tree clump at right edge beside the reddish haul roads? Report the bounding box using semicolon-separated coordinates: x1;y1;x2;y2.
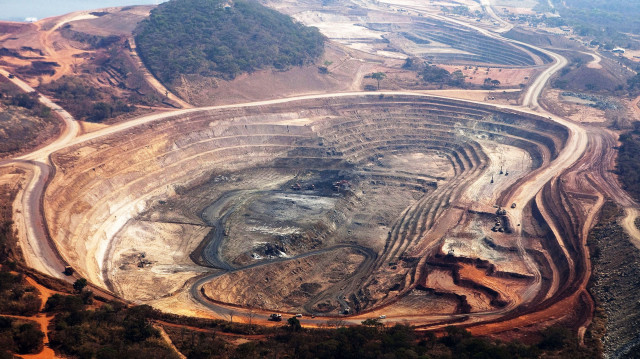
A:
616;122;640;200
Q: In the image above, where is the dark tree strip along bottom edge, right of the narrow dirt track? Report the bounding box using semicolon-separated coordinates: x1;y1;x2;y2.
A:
169;318;594;359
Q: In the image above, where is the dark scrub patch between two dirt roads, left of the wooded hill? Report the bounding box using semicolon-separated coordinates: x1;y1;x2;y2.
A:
42;76;136;122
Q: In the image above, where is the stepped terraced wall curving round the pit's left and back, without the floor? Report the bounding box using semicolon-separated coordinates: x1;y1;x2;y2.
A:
44;94;568;310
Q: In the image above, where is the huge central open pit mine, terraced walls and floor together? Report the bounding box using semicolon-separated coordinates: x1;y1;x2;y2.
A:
43;93;595;332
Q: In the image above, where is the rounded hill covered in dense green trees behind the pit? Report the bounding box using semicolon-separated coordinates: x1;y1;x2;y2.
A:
136;0;325;84
